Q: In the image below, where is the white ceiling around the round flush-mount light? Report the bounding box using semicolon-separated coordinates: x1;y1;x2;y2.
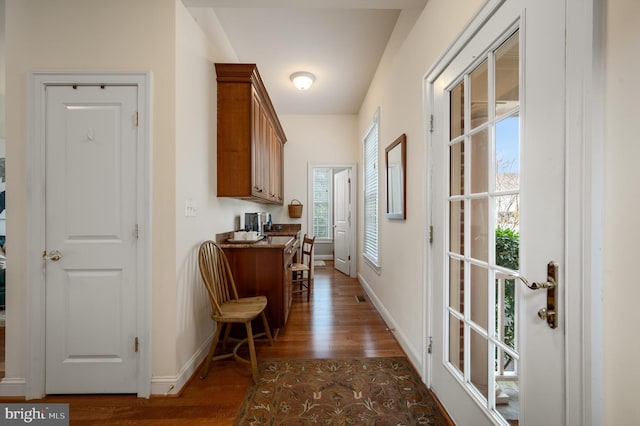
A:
183;0;427;114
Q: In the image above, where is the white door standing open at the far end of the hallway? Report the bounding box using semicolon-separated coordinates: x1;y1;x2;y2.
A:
333;169;351;275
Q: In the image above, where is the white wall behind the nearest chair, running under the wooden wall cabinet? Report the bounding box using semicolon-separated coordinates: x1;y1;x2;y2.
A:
174;4;273;390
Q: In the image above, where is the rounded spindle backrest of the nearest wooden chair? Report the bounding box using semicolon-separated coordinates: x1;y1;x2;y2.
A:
198;240;238;315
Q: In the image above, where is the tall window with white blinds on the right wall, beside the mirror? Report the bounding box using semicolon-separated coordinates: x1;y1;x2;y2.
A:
363;110;380;271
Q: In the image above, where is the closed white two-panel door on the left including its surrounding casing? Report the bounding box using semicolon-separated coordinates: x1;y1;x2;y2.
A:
25;73;151;398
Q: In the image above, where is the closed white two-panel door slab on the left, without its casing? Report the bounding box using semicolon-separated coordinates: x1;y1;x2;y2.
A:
43;85;139;394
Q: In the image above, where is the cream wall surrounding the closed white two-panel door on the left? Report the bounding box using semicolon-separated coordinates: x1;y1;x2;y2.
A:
5;0;176;378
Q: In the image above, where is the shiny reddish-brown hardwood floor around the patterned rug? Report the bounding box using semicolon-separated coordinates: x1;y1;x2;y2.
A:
0;262;418;426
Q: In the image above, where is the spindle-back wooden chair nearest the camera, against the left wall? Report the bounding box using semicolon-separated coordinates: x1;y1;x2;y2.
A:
198;241;273;381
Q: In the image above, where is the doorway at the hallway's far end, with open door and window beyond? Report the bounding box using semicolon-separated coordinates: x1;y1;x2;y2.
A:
307;163;357;277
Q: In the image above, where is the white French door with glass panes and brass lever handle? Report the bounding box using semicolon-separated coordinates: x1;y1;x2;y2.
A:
427;0;565;425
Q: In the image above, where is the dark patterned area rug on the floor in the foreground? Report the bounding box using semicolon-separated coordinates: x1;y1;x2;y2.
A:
234;357;449;426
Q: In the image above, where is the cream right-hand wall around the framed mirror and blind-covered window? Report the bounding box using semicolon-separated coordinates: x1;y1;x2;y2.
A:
358;0;483;369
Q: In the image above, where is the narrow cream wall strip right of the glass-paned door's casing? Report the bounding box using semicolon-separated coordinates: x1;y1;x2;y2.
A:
603;0;640;425
